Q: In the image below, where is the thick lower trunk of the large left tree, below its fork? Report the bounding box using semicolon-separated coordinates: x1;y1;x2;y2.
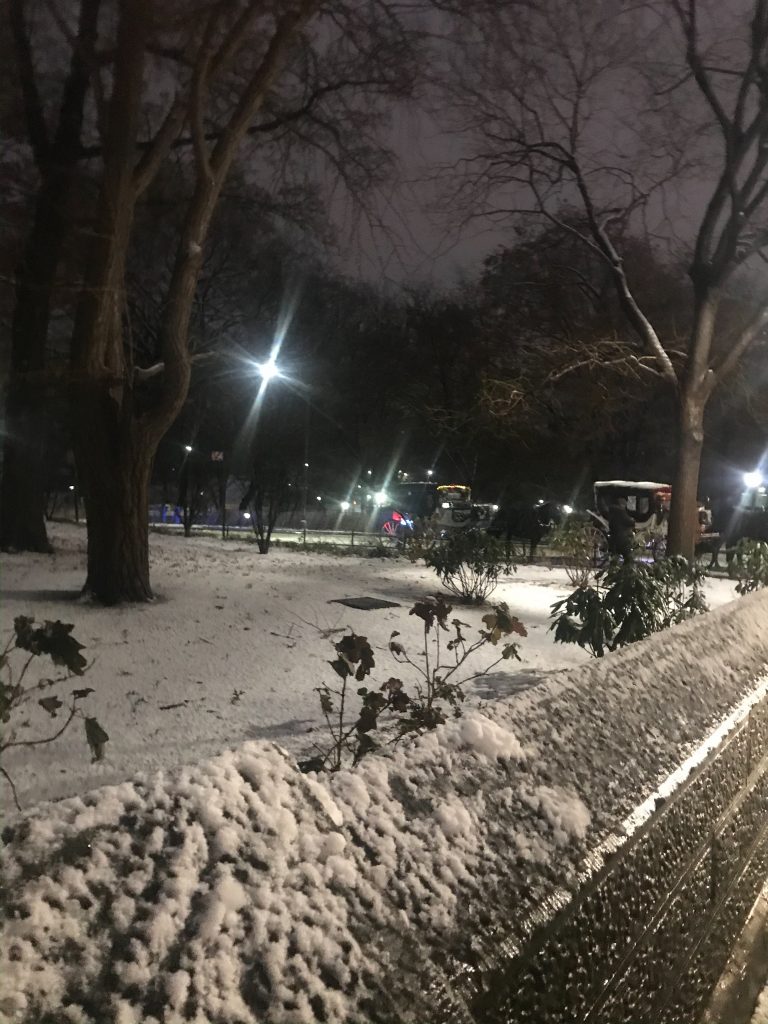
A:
73;387;157;604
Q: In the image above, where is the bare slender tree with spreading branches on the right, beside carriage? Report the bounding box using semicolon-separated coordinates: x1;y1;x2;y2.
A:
444;0;768;557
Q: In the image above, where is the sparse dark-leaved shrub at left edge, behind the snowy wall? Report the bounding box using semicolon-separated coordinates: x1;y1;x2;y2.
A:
0;615;110;810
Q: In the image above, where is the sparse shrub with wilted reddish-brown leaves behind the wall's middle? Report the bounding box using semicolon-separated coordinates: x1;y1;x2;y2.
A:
299;597;526;771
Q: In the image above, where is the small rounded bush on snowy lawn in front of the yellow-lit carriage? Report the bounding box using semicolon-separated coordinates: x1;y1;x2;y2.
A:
423;529;515;604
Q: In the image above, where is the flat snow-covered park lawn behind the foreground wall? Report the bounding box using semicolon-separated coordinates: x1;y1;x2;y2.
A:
0;524;734;808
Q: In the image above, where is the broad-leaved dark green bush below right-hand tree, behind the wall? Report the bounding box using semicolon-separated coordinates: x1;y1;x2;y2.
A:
550;557;707;657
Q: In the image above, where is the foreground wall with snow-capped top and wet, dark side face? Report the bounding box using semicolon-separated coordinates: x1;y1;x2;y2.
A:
0;594;768;1024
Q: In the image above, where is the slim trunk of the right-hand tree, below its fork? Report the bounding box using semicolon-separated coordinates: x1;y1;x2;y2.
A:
667;394;706;562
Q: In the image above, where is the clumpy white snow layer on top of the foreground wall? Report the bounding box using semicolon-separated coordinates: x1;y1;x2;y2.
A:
0;594;768;1024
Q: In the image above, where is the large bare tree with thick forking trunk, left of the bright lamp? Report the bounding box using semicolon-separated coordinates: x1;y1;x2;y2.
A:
4;0;416;603
